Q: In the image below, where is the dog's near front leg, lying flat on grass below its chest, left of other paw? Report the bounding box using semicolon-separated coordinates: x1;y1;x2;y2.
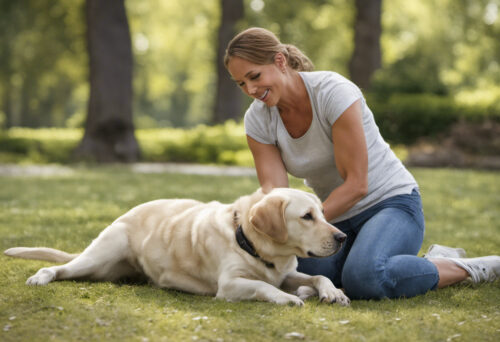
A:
217;276;304;306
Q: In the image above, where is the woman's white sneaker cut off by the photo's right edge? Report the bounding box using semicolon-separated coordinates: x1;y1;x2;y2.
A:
446;255;500;284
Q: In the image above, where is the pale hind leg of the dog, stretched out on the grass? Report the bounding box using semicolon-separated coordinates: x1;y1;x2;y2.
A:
26;223;135;285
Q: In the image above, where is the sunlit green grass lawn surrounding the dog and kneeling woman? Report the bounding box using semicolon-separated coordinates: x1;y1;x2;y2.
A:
0;167;500;342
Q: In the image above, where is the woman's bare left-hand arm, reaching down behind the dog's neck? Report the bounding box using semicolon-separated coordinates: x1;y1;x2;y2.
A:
247;135;288;193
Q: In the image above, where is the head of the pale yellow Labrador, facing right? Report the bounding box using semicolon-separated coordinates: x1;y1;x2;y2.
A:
249;188;346;257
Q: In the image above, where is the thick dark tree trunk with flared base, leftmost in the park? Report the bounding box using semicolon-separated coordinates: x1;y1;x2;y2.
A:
75;0;139;162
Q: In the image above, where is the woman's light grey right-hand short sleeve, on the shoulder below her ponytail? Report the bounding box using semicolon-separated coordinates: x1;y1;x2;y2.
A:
321;79;363;126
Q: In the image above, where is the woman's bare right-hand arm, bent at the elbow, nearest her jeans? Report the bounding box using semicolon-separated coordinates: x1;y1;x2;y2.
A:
323;100;368;221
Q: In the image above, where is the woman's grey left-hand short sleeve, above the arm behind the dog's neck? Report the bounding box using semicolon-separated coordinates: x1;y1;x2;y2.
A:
244;102;276;145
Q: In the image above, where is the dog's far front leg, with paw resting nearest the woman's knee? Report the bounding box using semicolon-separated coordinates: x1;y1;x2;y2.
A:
281;271;351;306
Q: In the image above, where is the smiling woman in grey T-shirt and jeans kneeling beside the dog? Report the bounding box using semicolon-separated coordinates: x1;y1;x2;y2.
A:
225;28;500;299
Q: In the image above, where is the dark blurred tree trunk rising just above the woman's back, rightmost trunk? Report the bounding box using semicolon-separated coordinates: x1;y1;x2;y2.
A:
349;0;382;89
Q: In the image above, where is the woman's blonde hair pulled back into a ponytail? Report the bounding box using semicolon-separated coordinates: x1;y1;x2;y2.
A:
224;27;314;71
